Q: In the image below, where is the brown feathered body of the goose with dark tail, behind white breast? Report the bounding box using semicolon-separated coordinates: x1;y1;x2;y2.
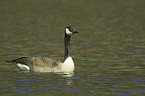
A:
8;57;62;72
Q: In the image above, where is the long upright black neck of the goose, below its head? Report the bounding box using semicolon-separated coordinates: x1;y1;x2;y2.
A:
64;32;71;59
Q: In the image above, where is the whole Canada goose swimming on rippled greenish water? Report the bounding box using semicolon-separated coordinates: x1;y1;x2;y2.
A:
7;26;79;72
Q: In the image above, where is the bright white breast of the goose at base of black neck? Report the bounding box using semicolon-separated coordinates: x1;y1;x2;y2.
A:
62;57;74;72
